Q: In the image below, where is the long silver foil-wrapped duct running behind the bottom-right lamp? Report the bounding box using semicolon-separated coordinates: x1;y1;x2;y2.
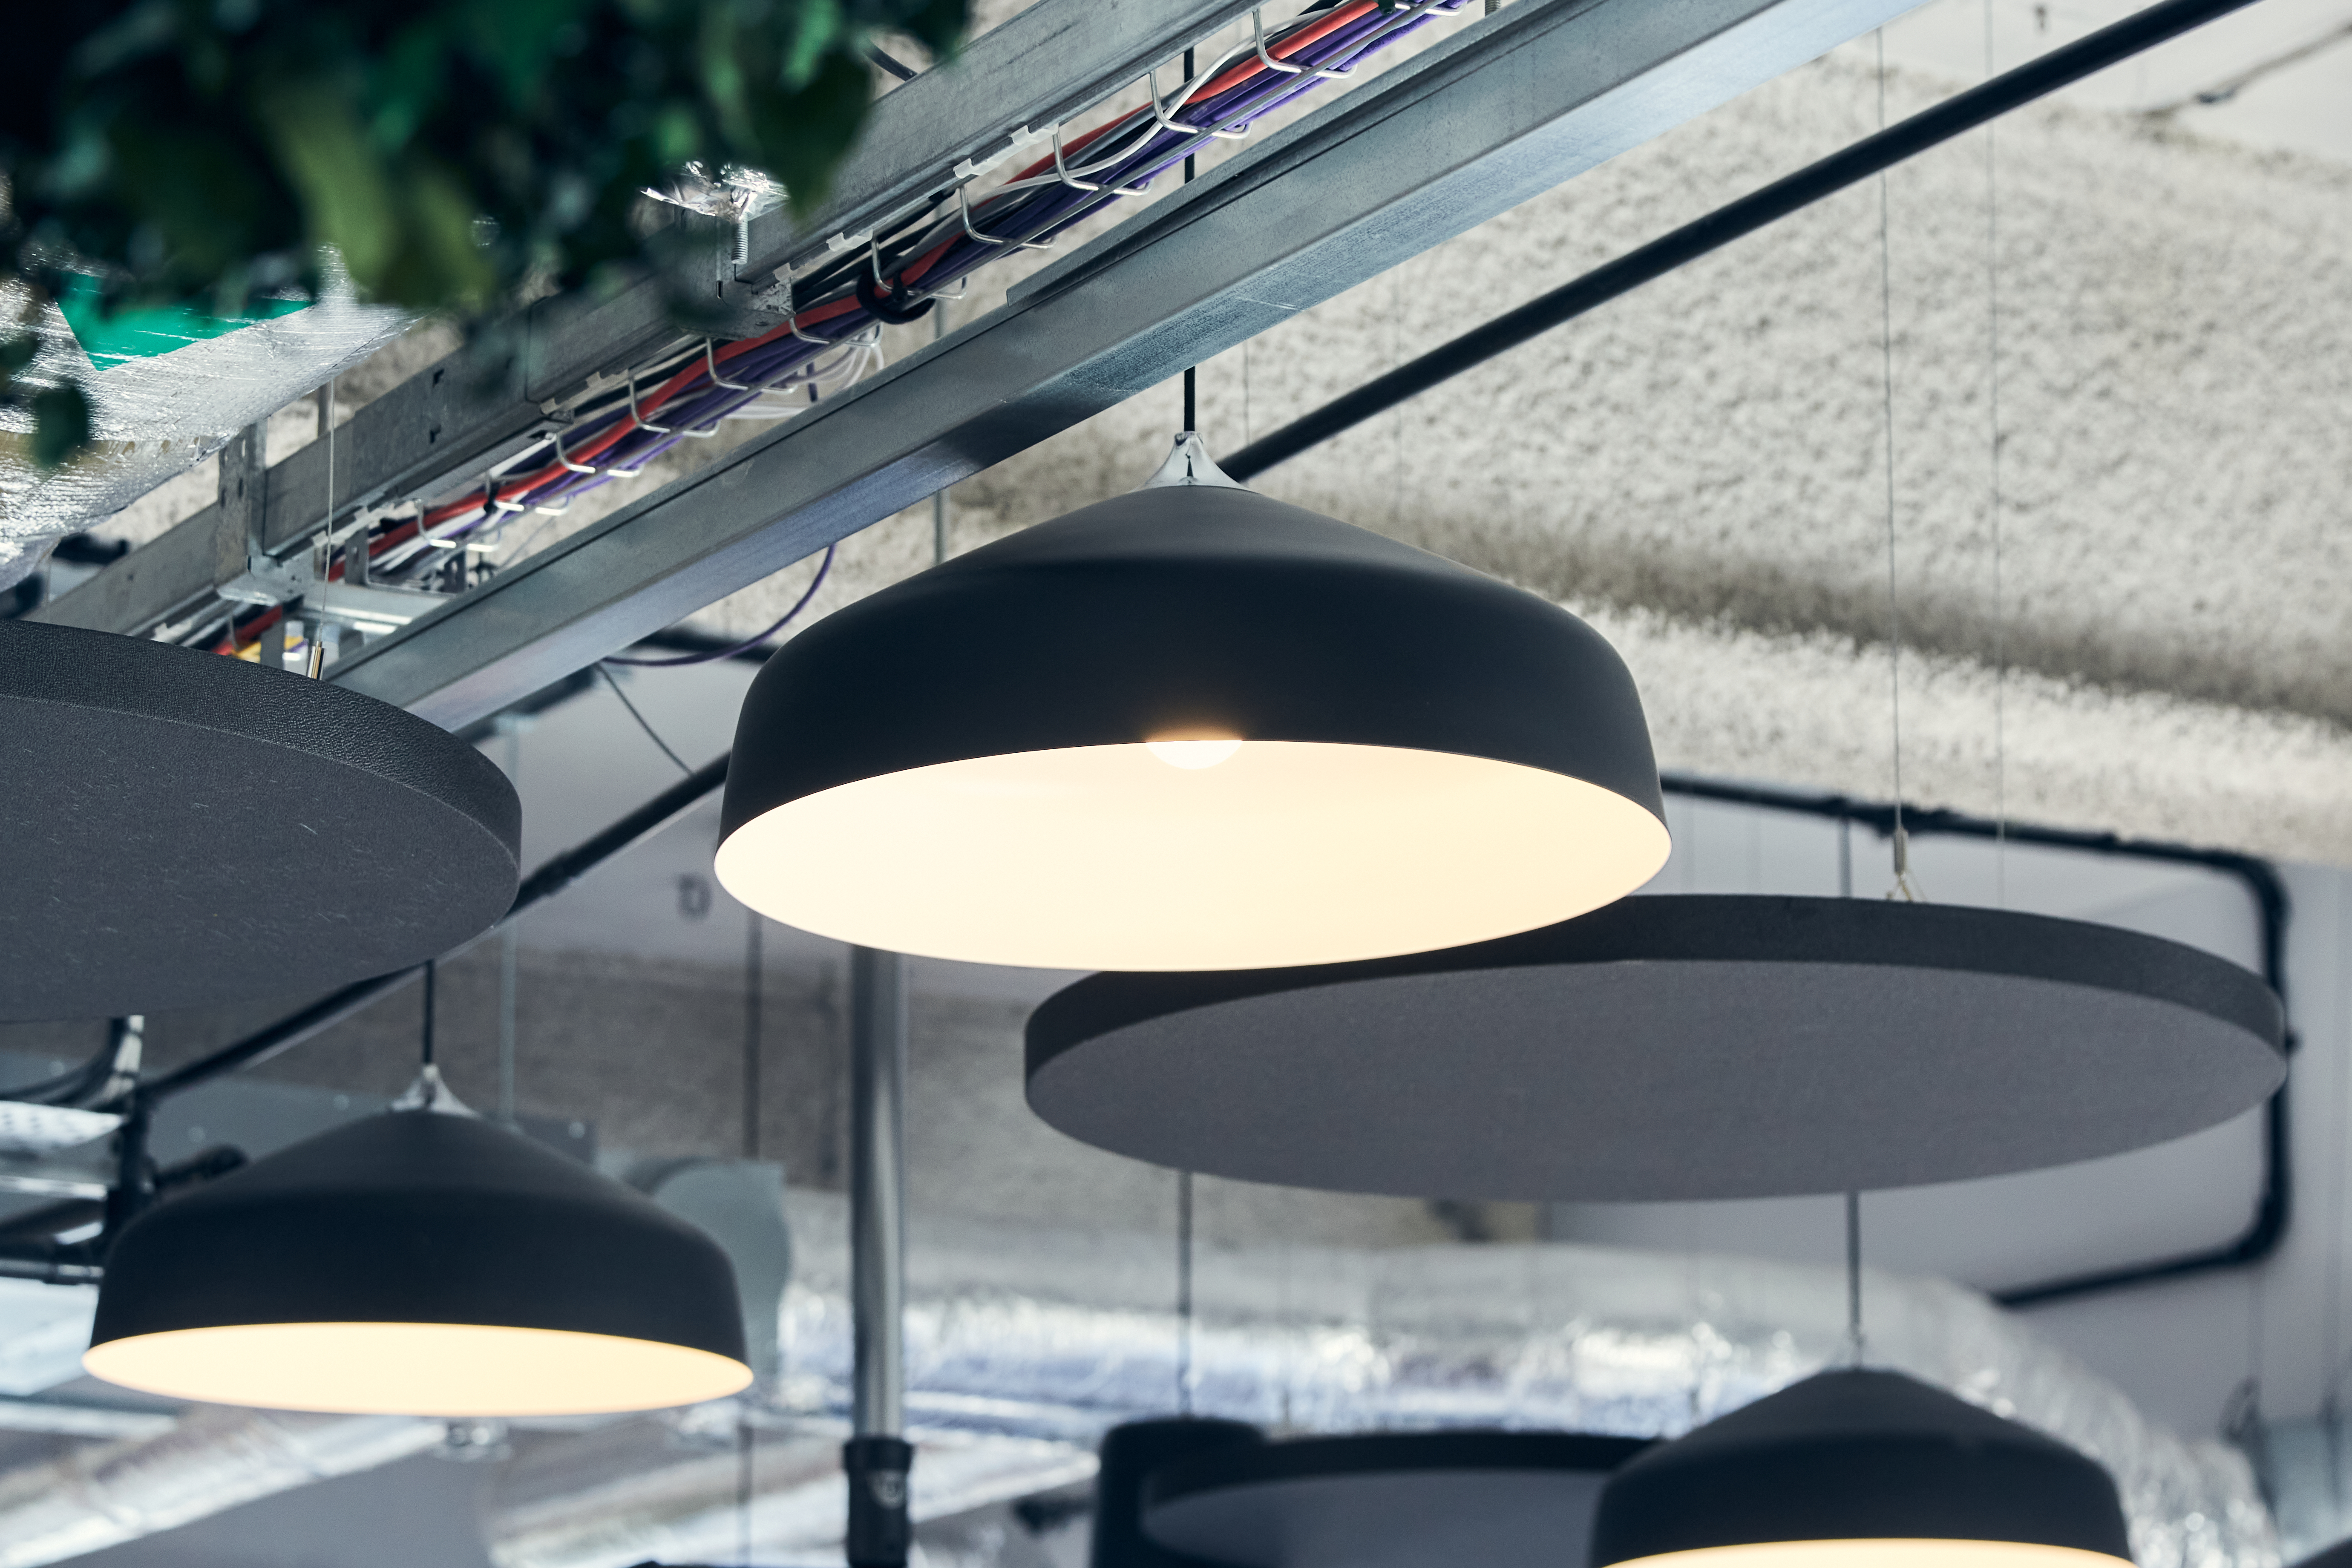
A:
783;1194;2279;1568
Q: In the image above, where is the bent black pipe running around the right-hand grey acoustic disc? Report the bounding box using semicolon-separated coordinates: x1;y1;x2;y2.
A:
1661;774;2295;1307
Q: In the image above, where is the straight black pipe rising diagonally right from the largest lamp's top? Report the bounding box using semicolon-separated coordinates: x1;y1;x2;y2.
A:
1218;0;2253;482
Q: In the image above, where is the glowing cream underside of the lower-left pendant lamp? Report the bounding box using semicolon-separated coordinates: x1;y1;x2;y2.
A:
82;1323;750;1418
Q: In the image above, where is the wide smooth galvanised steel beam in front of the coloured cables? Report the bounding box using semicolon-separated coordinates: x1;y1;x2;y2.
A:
334;0;1912;726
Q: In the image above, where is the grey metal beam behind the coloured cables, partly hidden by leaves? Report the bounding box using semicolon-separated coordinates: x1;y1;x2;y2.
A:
31;0;1249;633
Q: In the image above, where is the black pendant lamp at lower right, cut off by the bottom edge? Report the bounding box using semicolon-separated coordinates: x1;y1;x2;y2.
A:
1592;1370;2131;1568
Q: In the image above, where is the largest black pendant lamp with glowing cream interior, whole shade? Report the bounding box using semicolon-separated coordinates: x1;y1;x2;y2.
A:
717;435;1667;971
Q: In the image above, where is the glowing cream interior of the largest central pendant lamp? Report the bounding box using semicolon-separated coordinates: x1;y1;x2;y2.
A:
717;736;1667;971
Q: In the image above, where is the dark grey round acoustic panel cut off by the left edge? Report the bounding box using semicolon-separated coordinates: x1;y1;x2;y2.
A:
0;621;522;1020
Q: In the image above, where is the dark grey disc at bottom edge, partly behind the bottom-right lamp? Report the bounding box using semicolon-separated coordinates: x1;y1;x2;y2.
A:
1143;1432;1651;1568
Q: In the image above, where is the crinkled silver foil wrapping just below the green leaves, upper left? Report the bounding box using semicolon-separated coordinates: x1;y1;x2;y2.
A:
0;273;414;590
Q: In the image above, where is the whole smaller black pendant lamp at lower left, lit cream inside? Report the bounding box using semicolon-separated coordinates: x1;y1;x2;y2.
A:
82;1112;750;1415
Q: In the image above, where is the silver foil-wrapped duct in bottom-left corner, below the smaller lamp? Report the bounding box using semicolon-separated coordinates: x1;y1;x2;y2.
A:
0;1408;442;1568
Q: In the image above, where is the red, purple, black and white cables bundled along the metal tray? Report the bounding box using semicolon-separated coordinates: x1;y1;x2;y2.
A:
219;0;1468;653
